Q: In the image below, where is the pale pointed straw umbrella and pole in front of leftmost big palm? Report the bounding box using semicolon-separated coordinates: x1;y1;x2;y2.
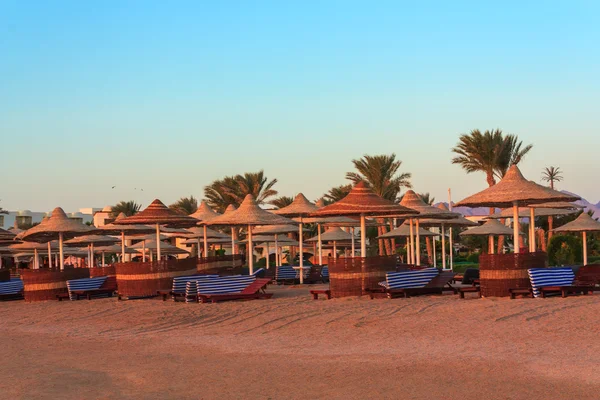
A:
206;194;296;274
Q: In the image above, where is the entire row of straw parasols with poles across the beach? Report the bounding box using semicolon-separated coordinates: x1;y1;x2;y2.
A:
2;166;600;277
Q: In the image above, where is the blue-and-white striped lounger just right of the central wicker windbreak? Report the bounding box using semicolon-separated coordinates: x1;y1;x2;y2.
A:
367;268;446;299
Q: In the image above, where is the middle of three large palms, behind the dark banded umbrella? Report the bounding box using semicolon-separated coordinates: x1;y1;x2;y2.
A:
346;153;412;255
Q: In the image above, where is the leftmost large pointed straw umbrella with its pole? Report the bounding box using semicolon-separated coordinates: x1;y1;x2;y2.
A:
22;207;96;270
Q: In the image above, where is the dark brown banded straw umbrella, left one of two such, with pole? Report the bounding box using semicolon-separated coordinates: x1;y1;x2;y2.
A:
113;199;198;261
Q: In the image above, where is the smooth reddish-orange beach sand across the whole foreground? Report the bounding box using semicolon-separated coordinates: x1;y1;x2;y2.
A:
0;286;600;399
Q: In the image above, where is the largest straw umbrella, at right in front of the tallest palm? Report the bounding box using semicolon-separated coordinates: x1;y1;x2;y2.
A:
456;165;580;253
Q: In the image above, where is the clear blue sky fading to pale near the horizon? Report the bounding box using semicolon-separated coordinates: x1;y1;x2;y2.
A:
0;0;600;211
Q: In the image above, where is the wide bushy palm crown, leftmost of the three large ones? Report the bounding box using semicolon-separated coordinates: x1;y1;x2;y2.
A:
204;170;277;213
